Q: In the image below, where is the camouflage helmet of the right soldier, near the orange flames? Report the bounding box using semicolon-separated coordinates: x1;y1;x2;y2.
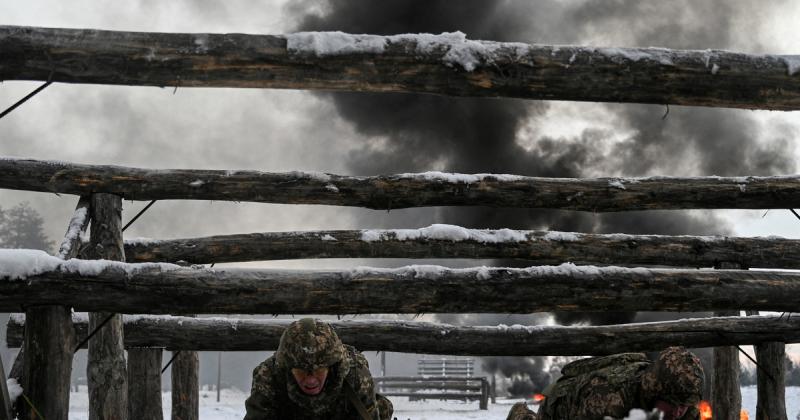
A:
642;347;705;405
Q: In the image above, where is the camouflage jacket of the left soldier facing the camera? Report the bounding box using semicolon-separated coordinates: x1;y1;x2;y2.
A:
244;346;392;420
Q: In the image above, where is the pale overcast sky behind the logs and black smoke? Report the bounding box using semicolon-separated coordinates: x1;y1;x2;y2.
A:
0;0;800;384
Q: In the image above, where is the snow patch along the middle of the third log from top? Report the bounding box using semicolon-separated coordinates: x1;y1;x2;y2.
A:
361;224;528;243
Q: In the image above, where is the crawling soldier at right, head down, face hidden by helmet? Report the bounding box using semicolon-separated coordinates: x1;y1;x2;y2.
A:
507;347;703;420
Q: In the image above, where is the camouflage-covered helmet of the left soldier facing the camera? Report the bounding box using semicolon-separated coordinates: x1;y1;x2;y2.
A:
275;318;345;371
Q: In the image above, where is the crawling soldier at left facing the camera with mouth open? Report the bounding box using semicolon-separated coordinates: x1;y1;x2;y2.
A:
244;318;393;420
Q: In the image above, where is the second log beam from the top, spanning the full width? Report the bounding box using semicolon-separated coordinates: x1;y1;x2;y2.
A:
0;158;800;212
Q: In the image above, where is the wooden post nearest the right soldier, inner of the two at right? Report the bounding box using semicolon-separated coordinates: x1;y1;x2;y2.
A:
711;263;742;420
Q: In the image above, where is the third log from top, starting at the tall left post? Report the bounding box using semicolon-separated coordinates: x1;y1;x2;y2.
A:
125;225;800;269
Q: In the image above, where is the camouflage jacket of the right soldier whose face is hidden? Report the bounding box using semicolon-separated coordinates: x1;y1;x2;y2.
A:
536;353;700;420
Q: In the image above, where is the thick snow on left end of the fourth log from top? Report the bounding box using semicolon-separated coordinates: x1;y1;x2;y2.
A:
0;249;181;281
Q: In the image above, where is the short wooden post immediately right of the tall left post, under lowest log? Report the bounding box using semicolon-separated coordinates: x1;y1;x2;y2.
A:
128;348;164;420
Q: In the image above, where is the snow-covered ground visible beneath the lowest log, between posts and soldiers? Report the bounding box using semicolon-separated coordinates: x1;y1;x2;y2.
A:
69;387;800;420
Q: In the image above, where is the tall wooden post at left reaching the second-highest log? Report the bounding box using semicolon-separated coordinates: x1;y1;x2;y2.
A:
87;194;128;420
